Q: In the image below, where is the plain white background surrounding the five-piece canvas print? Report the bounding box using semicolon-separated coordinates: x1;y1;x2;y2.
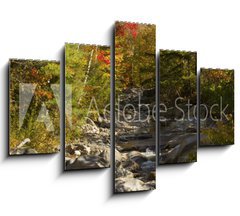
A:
0;0;240;216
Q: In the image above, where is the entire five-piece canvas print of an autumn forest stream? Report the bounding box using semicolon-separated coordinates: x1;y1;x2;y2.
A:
7;21;234;196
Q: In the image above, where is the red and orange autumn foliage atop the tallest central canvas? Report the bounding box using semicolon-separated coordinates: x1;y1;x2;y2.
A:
115;22;155;92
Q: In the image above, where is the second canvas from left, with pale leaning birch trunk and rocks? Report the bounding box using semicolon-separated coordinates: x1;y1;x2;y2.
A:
65;44;110;170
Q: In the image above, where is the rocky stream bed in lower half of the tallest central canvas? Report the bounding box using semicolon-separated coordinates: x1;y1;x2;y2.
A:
115;88;156;192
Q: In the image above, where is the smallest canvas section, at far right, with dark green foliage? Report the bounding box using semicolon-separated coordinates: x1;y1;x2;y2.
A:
199;68;234;146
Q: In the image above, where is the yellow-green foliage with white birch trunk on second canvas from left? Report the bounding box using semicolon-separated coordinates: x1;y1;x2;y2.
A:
65;44;110;144
